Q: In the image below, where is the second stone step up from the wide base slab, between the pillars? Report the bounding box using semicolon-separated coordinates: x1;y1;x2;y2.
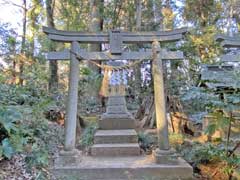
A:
94;129;138;144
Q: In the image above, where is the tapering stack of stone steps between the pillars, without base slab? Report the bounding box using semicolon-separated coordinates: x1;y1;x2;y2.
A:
91;96;140;156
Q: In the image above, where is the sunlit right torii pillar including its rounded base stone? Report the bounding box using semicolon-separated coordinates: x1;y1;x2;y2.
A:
152;41;177;164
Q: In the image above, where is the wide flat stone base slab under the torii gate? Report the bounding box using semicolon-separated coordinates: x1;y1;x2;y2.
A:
51;155;193;180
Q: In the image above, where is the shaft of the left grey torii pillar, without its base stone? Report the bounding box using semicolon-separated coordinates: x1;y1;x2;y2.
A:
64;41;79;151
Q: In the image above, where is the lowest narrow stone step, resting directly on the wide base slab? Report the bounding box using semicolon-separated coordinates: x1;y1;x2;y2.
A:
91;143;140;156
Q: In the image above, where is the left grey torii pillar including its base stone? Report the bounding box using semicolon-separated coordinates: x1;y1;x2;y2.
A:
60;41;80;164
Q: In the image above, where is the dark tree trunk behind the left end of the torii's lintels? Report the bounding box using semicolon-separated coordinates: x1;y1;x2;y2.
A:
46;0;58;92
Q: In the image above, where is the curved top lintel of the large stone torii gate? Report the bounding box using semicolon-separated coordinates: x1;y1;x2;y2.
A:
43;27;187;43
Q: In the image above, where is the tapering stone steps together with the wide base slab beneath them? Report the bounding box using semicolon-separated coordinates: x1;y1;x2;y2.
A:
53;97;193;180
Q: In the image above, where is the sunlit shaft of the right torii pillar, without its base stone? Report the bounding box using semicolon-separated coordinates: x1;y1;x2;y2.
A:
152;41;169;150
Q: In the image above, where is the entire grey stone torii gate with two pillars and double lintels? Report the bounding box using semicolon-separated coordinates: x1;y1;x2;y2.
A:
43;27;187;162
